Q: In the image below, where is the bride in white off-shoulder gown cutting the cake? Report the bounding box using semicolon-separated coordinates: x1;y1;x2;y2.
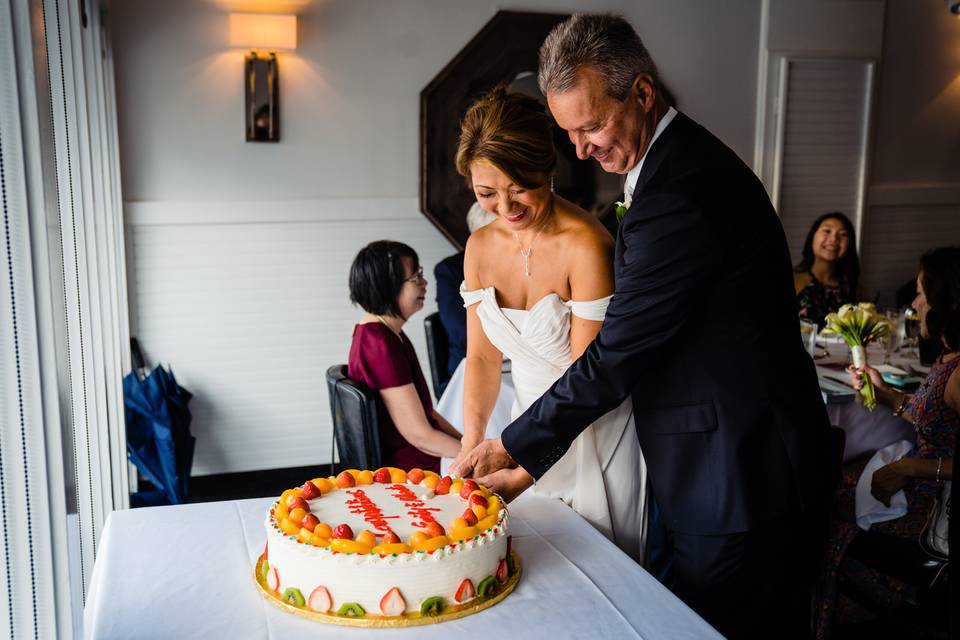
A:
456;89;646;561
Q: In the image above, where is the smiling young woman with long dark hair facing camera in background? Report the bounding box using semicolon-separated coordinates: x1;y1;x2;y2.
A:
793;211;860;327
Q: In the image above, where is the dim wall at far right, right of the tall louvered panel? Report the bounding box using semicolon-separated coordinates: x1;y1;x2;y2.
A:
861;0;960;305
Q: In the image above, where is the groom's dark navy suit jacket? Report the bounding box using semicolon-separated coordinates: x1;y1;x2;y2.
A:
502;114;829;535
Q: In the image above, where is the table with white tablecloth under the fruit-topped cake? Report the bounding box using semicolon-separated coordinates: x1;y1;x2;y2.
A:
84;496;721;640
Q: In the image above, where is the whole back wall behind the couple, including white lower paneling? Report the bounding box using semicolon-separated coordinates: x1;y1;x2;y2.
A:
112;0;760;474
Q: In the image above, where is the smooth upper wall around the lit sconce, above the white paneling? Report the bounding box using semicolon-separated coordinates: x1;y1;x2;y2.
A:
112;0;759;201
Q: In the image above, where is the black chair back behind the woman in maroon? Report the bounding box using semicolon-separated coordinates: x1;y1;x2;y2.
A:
327;364;383;469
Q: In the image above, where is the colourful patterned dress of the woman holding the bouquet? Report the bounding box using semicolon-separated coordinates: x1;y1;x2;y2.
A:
814;357;960;639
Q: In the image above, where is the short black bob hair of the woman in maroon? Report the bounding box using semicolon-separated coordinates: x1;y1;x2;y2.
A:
350;240;420;316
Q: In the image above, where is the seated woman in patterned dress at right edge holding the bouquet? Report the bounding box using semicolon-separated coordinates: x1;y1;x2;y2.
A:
817;247;960;638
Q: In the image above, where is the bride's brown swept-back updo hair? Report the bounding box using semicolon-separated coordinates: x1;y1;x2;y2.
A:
456;87;557;190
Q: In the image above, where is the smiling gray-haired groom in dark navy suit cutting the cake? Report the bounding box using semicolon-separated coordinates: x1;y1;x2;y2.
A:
454;14;833;638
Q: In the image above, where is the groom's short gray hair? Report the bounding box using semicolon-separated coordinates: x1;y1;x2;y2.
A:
537;13;660;100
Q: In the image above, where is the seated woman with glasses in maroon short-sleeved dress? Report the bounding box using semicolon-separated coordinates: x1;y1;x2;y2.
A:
347;240;460;472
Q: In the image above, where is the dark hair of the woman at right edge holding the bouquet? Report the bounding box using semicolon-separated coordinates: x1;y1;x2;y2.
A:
920;247;960;351
